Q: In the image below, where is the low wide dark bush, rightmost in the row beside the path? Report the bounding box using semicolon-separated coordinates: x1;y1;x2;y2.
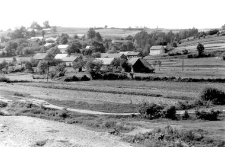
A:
195;109;220;120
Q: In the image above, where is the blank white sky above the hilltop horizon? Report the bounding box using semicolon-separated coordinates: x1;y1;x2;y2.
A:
0;0;225;30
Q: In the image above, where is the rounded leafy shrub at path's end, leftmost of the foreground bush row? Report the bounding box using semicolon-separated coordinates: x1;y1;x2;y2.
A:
139;103;164;119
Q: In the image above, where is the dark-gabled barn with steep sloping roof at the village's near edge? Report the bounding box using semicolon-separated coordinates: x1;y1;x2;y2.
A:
128;58;155;73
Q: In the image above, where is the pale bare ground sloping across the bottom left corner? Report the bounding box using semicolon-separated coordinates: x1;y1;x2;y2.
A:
0;116;131;147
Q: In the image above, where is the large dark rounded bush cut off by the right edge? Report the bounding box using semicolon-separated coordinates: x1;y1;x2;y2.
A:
200;87;225;105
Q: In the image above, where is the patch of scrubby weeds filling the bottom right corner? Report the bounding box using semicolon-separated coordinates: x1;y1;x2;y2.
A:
124;126;225;147
